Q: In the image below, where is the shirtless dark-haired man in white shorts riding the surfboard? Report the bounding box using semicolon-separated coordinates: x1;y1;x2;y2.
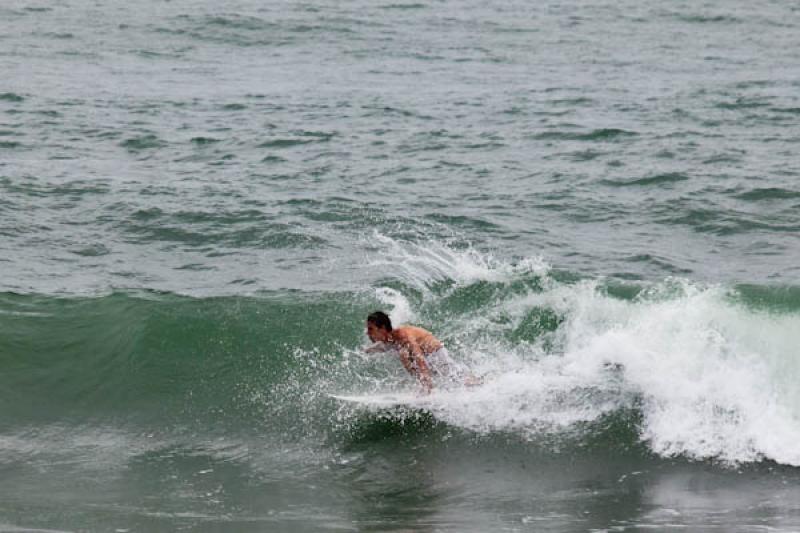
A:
367;311;458;392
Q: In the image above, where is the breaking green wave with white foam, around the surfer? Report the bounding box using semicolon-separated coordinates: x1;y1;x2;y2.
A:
0;236;800;466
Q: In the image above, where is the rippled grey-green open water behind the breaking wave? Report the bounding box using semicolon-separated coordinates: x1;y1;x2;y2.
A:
0;2;800;293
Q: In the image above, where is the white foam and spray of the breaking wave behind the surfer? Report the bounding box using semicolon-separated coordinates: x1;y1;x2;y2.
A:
362;245;800;465
